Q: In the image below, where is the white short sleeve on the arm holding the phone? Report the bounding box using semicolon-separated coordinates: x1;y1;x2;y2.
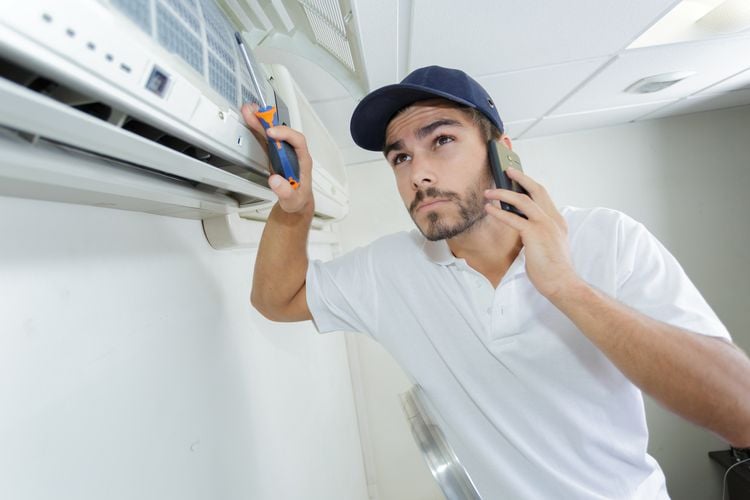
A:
617;217;731;340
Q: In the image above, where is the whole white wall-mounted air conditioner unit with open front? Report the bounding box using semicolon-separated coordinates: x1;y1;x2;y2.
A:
0;0;348;236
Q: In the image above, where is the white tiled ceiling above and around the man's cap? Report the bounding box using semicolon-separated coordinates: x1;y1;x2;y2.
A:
234;0;750;164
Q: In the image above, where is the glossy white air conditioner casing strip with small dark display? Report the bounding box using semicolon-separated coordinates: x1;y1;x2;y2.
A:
0;0;273;173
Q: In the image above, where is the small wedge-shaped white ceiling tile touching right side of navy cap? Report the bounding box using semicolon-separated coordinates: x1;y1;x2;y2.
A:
477;57;609;121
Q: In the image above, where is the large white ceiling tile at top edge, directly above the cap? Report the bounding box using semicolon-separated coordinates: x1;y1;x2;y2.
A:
408;0;677;76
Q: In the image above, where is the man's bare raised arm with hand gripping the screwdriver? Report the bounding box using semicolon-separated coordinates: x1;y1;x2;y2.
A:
242;105;315;321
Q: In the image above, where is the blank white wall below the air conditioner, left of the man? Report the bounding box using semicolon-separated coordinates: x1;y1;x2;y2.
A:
0;198;367;500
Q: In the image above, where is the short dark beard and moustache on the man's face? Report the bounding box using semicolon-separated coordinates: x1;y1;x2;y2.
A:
409;170;493;241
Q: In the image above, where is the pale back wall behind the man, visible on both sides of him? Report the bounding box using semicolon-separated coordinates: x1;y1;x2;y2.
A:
342;107;750;500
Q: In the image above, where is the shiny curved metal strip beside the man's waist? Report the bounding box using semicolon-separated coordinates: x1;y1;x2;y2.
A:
401;385;482;500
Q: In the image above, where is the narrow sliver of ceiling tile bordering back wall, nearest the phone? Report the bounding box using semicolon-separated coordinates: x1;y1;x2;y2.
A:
521;101;670;139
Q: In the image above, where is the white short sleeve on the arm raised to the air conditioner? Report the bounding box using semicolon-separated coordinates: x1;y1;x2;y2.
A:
306;248;378;333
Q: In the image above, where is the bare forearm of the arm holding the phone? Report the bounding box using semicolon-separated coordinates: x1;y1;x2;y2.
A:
551;282;750;447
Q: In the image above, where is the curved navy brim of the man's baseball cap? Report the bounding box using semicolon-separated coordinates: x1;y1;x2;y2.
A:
349;83;476;151
